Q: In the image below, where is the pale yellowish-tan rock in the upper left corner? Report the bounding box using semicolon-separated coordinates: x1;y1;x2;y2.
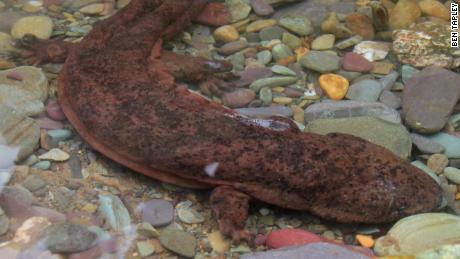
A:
11;16;53;39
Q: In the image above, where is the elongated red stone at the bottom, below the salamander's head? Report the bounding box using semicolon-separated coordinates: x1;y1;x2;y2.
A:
267;228;324;249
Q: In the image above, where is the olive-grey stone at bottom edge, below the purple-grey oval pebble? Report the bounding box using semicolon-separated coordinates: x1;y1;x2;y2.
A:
160;227;197;258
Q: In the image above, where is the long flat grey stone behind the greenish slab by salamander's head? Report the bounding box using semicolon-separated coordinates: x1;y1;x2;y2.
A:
305;101;401;123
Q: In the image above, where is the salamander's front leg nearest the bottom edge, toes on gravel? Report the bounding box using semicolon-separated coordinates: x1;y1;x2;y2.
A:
210;186;251;243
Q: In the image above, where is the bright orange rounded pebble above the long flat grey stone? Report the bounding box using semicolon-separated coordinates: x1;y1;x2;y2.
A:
319;74;349;100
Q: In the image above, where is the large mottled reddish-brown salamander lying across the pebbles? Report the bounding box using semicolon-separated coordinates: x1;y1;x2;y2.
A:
20;0;441;244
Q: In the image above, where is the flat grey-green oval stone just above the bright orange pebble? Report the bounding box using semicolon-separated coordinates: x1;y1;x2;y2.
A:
300;51;340;73
